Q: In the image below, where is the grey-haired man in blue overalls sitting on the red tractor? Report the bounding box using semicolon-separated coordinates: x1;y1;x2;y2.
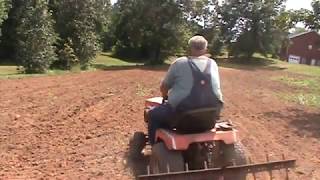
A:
148;36;223;144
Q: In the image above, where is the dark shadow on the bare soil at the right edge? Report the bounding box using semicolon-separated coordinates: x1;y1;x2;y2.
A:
265;108;320;138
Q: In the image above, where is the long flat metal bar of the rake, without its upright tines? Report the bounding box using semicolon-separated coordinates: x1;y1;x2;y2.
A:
138;159;296;180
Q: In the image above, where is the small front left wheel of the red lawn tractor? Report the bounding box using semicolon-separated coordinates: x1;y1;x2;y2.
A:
129;132;146;158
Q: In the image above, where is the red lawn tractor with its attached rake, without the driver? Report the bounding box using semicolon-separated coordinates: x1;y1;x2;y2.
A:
130;97;295;180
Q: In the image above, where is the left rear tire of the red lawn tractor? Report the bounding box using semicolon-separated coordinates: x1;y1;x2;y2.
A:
150;142;184;174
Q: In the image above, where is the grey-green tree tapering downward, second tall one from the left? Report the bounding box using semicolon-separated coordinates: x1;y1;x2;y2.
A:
50;0;110;69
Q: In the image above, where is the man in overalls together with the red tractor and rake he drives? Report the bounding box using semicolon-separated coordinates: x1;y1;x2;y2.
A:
130;36;295;180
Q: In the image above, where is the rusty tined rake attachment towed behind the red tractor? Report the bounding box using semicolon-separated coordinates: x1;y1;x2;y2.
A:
138;156;295;180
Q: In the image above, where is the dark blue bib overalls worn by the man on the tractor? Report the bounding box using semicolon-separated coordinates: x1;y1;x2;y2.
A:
148;59;222;144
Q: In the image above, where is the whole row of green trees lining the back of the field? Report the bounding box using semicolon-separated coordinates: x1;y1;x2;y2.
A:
0;0;320;73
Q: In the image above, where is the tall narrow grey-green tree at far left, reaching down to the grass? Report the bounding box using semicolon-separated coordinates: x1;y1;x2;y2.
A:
16;0;56;73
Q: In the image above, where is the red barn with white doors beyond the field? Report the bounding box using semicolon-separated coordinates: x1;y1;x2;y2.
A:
281;31;320;66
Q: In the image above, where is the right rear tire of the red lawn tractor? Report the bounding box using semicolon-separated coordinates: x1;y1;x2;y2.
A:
221;142;247;180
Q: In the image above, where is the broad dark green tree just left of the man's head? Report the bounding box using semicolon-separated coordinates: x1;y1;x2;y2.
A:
111;0;188;64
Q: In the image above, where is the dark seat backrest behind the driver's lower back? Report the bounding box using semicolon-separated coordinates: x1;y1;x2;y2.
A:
175;108;218;134
